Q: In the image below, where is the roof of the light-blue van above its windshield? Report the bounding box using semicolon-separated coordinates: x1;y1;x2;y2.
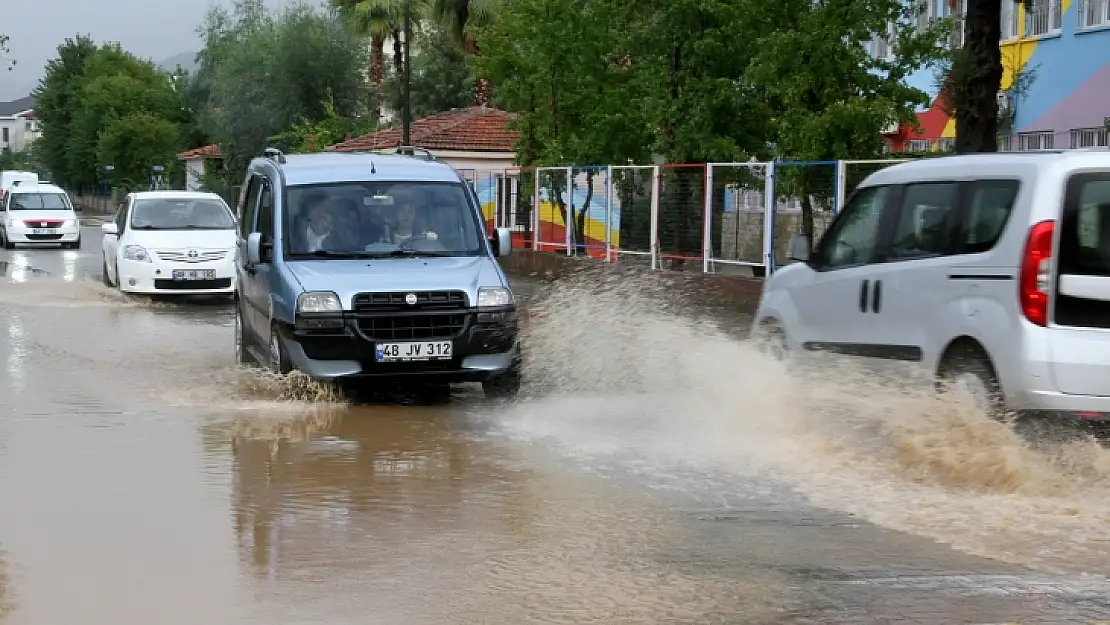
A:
268;152;460;187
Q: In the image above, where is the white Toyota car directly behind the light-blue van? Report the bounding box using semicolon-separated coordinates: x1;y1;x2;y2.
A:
101;191;235;295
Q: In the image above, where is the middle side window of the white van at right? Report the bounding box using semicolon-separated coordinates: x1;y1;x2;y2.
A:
887;182;958;261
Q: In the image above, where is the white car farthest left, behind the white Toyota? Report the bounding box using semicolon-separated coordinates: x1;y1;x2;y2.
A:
0;180;81;250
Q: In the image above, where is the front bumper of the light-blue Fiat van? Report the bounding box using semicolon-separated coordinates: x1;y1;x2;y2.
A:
280;309;521;383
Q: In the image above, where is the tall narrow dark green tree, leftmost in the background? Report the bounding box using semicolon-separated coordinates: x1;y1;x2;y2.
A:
32;34;97;185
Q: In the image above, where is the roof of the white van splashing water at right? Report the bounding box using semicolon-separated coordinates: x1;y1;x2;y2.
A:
860;148;1110;187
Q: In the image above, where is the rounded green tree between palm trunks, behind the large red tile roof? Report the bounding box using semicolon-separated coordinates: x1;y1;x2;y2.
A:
383;23;474;119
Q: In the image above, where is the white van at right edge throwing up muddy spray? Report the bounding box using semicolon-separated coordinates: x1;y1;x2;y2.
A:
753;149;1110;420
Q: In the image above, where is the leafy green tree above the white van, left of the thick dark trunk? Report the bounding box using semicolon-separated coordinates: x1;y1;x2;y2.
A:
746;0;951;249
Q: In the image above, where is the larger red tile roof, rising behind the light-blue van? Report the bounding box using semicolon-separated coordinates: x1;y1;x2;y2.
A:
329;107;521;152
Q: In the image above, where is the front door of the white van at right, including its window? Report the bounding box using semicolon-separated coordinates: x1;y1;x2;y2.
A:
789;187;897;357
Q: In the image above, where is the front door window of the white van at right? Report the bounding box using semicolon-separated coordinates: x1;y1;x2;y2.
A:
816;187;890;270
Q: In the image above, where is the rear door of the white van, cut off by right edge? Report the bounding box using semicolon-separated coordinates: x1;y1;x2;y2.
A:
1049;172;1110;396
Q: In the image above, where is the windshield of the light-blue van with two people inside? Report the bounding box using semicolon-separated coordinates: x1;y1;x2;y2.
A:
285;182;483;258
